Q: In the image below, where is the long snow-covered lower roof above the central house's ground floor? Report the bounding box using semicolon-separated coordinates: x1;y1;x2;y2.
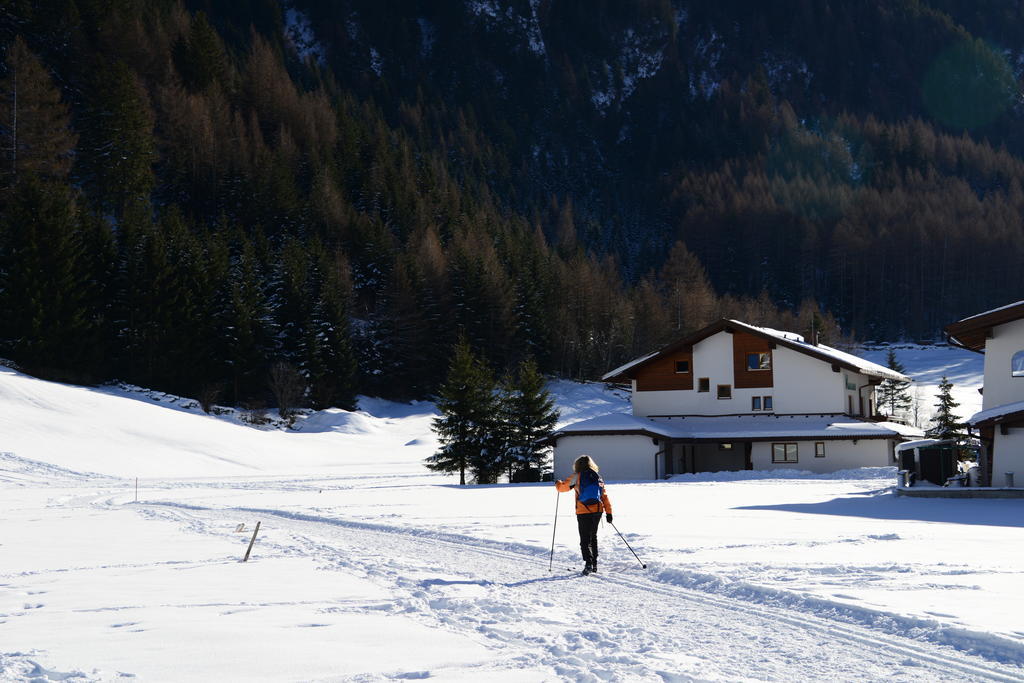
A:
554;413;922;441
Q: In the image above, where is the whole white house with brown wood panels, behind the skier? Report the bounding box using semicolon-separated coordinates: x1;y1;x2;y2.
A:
551;319;921;479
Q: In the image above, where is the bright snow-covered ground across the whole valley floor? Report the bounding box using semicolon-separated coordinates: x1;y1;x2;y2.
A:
0;349;1024;681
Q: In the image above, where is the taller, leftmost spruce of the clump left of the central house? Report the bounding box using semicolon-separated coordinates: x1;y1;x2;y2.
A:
426;337;500;484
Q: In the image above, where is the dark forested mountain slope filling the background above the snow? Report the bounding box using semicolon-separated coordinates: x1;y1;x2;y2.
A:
0;0;1024;405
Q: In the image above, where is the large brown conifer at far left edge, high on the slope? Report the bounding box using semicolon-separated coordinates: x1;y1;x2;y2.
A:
0;36;77;189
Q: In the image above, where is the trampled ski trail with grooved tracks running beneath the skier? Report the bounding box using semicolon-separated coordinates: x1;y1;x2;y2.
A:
56;482;1024;681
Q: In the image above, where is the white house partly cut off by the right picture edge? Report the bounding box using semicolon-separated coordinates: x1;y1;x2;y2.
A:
946;301;1024;485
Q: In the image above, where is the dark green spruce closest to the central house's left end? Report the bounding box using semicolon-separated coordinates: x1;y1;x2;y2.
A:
501;358;558;481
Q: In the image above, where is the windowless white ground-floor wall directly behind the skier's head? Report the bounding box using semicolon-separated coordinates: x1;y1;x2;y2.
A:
554;434;665;481
